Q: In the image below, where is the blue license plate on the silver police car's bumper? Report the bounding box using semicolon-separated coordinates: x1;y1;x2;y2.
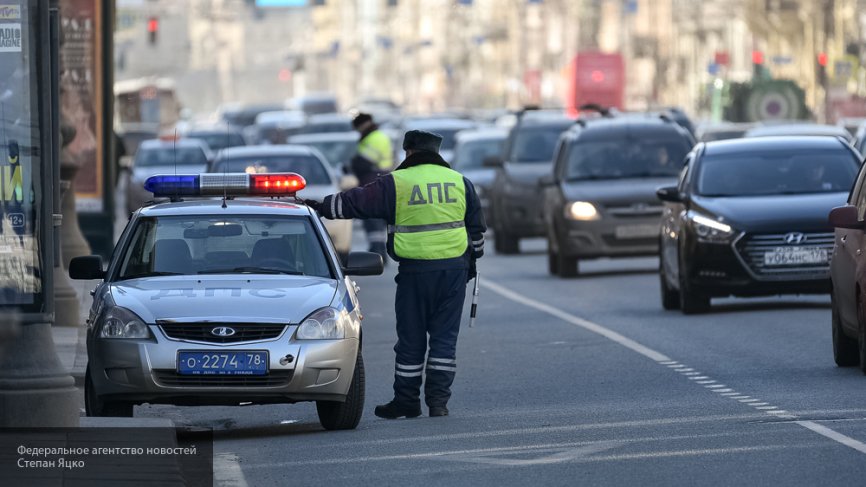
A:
177;350;268;375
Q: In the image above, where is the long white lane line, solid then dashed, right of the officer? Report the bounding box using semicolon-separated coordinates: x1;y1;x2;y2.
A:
482;281;866;460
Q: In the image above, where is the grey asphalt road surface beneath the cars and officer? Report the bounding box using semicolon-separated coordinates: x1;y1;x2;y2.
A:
136;241;866;486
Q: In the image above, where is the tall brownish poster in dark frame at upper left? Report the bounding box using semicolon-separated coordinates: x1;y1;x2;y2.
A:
60;0;104;213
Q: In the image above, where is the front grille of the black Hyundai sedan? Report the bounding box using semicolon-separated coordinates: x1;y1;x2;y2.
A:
736;232;835;280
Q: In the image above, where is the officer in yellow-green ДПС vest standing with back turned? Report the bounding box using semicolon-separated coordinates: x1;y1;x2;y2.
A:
306;130;487;419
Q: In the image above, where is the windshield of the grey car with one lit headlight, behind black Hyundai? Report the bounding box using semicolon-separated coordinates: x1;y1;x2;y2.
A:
565;138;690;180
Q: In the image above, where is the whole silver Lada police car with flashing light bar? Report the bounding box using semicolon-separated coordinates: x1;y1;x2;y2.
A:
69;173;382;429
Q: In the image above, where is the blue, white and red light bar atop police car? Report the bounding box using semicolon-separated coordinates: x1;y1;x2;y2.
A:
144;172;307;198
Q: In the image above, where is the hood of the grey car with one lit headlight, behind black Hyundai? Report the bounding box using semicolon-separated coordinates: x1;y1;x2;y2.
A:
562;177;677;207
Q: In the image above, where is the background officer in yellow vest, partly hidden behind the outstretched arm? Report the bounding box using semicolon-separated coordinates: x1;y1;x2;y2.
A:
351;113;394;263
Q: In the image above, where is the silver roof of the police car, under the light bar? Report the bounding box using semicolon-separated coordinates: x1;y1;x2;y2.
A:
140;198;311;216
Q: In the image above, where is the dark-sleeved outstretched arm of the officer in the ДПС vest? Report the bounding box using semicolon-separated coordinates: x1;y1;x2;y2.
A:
319;176;395;221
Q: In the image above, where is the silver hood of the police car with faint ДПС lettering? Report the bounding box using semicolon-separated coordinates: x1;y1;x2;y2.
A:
110;274;337;323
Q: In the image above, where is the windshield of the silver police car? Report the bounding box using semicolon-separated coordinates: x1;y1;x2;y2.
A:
118;215;332;279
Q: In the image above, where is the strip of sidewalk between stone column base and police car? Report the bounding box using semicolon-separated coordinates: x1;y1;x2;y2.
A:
51;281;99;387
